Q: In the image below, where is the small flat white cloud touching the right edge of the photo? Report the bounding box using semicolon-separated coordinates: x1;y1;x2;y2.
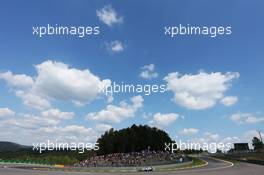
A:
229;112;264;124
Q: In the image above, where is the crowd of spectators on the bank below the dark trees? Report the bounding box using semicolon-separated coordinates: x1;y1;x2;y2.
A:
78;151;184;167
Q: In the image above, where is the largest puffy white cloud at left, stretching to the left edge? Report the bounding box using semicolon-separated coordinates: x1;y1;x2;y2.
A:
1;60;111;110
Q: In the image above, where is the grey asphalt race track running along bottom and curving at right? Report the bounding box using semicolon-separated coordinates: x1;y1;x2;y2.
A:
0;158;264;175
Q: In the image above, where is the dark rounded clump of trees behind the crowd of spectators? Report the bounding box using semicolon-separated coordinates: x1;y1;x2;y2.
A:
97;125;173;155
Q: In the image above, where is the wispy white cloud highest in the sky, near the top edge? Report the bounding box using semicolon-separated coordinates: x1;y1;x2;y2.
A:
96;5;123;27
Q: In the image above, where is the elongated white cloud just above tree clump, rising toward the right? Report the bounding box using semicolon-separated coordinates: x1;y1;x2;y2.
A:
86;96;144;123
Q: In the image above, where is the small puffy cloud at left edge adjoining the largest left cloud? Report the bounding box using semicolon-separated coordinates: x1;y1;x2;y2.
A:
0;71;34;88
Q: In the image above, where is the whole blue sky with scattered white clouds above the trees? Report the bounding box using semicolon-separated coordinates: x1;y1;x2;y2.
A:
0;0;264;150
